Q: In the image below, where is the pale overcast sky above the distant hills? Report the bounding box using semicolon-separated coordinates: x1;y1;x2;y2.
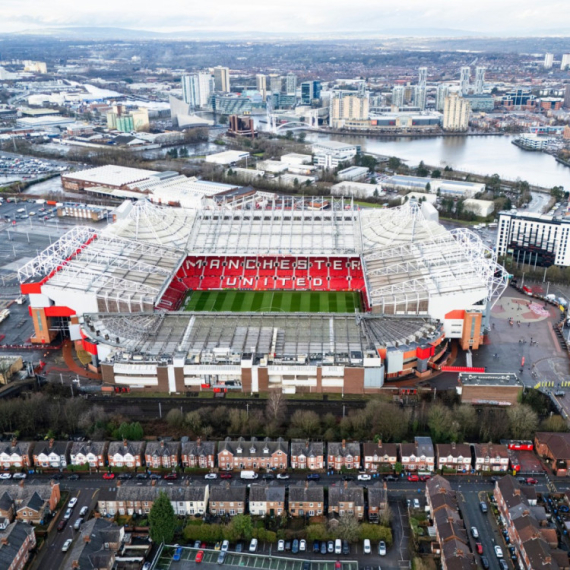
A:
0;0;570;35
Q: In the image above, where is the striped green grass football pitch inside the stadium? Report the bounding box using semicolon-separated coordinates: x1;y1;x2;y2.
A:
184;291;362;313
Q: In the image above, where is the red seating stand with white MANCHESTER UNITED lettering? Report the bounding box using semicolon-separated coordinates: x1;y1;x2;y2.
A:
157;255;367;311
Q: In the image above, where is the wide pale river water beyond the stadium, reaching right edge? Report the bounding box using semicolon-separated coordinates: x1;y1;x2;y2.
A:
298;132;570;190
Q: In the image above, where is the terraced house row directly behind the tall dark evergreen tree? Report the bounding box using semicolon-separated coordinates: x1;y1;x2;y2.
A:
97;481;209;516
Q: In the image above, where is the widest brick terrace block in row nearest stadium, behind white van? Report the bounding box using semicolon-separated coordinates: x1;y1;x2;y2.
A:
218;437;289;471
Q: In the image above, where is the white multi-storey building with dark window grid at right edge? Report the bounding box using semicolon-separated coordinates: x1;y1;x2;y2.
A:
497;212;570;267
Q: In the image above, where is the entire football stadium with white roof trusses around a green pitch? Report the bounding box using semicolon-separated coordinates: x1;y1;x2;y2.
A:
19;193;507;393
